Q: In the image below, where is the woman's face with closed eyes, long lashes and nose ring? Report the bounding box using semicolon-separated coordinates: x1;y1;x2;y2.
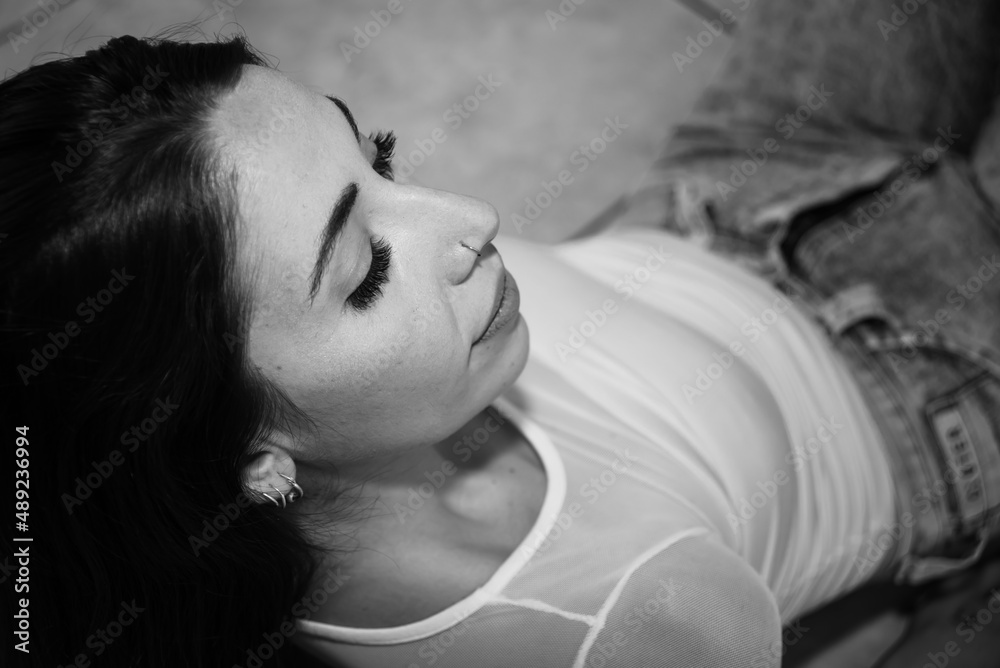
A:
212;66;528;462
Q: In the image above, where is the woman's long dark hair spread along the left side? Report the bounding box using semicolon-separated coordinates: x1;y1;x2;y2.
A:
0;36;324;668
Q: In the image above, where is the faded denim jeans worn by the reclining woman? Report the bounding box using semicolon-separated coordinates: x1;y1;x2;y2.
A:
615;0;1000;583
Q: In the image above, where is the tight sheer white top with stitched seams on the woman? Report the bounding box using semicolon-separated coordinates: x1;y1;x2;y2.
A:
295;230;895;668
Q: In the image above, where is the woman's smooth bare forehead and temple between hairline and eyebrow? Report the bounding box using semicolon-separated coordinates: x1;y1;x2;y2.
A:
209;66;359;326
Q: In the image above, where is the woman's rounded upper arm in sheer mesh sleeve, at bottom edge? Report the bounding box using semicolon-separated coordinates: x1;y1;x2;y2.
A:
576;537;781;668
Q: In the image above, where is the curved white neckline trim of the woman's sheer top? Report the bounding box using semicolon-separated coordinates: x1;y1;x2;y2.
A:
297;396;566;645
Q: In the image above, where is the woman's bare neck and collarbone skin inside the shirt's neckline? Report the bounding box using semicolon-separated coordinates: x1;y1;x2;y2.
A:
297;409;546;627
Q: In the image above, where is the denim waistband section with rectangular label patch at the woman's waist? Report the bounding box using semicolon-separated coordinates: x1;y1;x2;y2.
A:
820;321;1000;584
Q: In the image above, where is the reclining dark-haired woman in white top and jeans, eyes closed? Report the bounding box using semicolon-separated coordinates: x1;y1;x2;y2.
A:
0;0;1000;667
